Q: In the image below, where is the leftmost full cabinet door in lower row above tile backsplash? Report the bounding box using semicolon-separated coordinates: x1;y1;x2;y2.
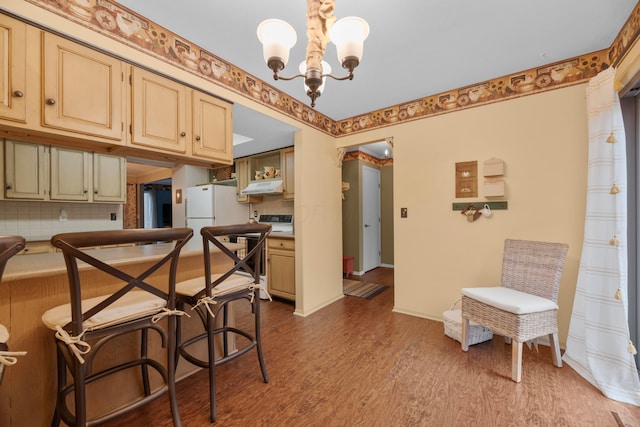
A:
4;140;49;200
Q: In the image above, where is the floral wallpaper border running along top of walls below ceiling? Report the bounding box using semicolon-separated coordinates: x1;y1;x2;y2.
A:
18;0;640;137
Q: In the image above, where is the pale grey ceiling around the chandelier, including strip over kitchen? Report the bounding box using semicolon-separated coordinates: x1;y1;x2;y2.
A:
119;0;637;157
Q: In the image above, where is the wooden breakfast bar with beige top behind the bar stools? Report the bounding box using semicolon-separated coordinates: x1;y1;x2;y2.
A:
0;244;232;427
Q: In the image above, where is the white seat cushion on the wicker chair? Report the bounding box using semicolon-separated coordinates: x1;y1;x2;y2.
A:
460;286;558;314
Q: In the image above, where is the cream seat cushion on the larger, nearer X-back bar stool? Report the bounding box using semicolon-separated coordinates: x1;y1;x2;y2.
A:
42;291;167;331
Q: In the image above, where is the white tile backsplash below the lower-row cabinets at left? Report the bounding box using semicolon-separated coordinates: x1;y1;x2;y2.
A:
0;200;122;241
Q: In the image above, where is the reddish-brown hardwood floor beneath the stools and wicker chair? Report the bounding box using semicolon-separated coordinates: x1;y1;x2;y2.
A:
102;269;640;427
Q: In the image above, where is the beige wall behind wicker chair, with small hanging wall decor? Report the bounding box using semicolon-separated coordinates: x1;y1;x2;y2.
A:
337;85;587;343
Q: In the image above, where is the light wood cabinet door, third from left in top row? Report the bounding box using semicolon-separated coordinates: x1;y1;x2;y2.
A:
131;67;190;155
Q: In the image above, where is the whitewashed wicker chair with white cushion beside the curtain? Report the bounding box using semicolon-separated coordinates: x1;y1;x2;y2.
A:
461;240;569;382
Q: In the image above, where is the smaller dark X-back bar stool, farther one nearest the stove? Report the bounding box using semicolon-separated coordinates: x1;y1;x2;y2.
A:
176;224;271;422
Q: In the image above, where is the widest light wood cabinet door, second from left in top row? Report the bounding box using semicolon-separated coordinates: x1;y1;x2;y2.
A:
40;32;127;143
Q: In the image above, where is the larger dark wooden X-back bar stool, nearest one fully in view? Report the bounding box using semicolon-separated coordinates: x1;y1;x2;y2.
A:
42;228;193;426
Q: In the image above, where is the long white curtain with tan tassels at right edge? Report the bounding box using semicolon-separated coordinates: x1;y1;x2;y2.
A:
563;67;640;405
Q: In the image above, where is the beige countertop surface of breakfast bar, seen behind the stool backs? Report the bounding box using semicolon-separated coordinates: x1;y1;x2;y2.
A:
2;243;242;281
